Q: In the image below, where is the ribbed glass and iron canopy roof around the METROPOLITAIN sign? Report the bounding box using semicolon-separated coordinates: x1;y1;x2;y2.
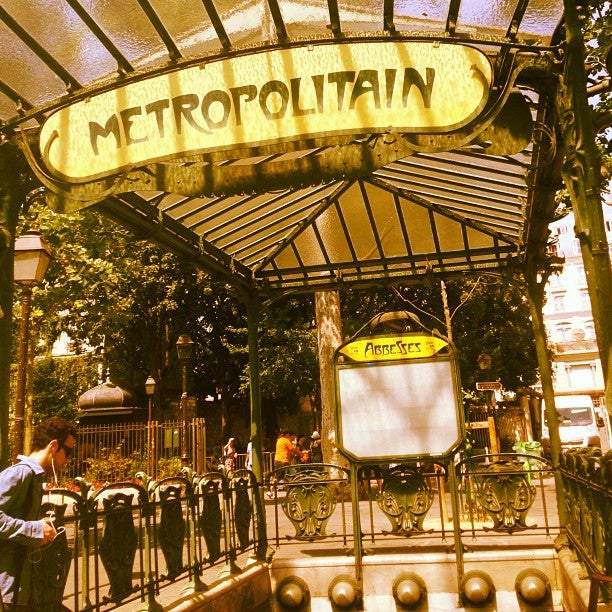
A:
0;0;563;294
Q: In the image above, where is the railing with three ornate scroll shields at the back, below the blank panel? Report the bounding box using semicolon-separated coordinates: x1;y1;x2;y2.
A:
266;453;559;547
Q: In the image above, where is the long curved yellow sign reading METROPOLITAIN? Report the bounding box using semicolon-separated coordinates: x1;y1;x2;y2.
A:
40;41;492;182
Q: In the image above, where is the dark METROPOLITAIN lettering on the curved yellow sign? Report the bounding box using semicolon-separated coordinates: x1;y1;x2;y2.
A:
89;67;436;156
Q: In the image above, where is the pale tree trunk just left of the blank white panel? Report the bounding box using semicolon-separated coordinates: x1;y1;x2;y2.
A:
315;291;348;466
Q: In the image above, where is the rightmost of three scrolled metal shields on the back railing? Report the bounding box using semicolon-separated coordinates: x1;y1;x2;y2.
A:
474;460;535;533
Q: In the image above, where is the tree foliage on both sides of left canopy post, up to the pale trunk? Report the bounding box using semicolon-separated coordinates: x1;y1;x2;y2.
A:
14;204;317;427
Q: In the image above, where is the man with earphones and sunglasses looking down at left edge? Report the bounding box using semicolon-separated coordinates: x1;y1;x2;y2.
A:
0;417;76;610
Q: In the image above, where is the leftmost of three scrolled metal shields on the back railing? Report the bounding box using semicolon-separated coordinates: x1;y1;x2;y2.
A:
281;466;336;540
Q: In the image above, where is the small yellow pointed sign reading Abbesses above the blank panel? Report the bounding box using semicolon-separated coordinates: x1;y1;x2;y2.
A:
338;334;448;361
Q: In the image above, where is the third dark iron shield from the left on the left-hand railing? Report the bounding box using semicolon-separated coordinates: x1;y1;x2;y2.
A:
158;485;185;578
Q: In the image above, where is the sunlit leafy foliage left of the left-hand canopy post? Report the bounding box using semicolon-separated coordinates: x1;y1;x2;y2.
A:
19;203;247;417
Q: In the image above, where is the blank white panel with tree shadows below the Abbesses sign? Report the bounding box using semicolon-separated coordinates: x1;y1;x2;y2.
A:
338;360;459;459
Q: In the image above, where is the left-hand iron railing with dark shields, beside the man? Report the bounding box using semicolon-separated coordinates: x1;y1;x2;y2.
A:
34;468;261;610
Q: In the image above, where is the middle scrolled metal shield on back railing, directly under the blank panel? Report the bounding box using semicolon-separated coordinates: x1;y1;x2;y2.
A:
377;467;434;537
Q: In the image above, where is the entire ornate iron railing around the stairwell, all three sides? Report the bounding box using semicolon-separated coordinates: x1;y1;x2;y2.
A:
34;452;612;610
